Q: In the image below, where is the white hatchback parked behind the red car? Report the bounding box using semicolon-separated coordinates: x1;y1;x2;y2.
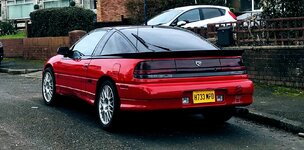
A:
147;5;236;28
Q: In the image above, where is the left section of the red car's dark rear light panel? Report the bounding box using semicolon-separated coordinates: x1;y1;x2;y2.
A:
134;60;176;79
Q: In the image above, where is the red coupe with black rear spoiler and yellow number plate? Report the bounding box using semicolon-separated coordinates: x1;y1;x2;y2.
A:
42;26;253;129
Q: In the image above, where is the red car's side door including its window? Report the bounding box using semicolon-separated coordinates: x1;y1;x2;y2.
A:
56;30;106;98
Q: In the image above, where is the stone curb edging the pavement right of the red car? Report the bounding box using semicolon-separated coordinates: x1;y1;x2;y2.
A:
235;108;304;134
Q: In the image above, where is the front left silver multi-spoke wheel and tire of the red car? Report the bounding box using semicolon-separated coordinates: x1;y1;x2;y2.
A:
42;67;56;106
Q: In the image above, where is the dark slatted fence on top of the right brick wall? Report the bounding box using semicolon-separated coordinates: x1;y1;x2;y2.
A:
188;17;304;46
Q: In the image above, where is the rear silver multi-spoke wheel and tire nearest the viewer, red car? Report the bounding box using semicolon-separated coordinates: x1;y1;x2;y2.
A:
96;81;120;131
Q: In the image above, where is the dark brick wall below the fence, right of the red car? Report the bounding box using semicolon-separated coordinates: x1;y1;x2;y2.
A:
226;46;304;88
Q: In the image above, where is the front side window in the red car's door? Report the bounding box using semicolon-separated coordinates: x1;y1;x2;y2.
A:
73;30;107;56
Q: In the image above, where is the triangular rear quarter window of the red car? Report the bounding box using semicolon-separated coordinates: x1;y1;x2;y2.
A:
101;32;135;55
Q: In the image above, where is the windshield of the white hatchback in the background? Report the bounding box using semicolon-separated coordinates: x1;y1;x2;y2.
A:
148;10;182;25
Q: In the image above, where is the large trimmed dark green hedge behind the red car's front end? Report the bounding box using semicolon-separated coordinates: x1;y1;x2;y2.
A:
29;7;95;37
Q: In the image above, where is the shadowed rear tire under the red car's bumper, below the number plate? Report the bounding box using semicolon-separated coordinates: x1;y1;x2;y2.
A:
202;107;235;124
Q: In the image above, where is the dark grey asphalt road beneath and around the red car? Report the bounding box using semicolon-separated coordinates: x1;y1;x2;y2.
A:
0;73;304;150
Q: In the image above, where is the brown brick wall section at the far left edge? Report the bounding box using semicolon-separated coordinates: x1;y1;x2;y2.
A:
0;39;23;57
